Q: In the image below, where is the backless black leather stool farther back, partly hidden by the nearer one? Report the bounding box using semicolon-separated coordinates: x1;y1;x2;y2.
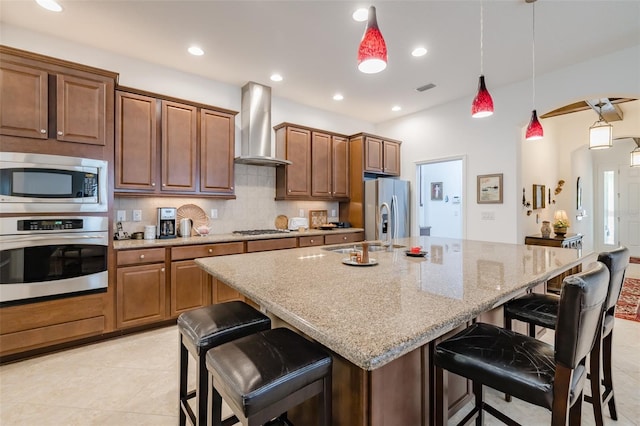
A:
178;301;271;426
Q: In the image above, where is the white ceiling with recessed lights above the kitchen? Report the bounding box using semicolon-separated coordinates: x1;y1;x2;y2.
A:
0;0;640;123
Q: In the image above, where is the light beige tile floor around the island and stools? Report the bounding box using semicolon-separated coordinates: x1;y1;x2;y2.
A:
0;265;640;426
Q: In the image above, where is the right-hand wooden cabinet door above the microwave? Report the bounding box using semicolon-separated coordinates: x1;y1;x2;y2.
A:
56;74;113;145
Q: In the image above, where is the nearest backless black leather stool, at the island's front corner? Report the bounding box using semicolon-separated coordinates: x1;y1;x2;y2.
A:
206;328;332;426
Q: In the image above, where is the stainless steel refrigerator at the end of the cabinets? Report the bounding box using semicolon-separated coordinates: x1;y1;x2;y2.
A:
364;178;410;240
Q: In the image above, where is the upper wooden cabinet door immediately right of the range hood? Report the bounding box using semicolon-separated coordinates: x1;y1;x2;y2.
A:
285;127;311;196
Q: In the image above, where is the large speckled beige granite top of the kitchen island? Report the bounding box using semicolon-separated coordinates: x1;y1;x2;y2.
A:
196;236;595;370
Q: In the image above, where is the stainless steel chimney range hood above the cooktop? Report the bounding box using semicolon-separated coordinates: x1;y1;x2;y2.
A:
235;81;291;167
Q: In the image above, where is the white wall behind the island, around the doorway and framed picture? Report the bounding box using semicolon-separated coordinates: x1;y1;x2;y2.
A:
376;45;640;243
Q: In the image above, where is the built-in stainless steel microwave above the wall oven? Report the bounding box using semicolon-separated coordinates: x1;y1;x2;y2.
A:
0;152;108;213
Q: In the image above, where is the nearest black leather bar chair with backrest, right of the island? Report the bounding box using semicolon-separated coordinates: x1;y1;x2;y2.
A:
434;262;609;426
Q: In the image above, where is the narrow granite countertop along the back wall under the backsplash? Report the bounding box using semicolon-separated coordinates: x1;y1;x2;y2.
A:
113;228;364;250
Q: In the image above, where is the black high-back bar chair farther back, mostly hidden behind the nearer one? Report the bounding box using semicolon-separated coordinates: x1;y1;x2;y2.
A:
504;247;630;426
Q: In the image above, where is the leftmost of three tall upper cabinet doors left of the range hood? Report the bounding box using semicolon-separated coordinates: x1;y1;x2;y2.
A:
115;92;158;190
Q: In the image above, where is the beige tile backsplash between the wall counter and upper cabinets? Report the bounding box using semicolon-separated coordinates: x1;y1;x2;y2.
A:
113;164;338;234
